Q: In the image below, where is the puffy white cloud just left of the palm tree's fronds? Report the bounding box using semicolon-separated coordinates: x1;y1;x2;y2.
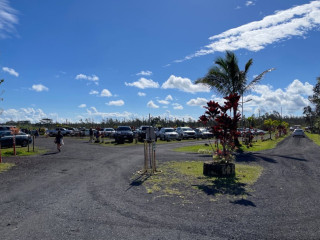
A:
161;75;210;93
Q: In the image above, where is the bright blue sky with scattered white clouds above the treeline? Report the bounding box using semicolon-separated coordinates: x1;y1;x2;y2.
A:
0;0;320;122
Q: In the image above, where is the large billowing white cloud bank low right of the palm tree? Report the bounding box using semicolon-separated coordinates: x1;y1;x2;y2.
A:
240;79;313;115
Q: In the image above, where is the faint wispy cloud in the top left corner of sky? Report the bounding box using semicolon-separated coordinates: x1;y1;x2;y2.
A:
0;0;19;38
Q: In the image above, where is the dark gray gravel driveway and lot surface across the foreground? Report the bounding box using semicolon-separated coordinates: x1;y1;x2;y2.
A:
0;137;320;240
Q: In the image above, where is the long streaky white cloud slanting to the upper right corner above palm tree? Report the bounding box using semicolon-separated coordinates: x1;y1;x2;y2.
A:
175;1;320;62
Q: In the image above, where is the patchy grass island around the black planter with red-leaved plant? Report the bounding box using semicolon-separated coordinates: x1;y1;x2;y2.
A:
131;161;263;200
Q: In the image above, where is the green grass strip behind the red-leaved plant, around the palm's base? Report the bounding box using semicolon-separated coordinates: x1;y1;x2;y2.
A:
174;136;286;154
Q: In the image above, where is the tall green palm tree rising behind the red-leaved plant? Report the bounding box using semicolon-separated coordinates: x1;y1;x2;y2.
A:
195;51;274;127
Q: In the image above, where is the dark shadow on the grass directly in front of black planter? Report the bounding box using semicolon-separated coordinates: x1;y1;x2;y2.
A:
193;177;249;196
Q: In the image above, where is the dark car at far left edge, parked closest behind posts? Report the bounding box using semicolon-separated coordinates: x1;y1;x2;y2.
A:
0;131;32;148
